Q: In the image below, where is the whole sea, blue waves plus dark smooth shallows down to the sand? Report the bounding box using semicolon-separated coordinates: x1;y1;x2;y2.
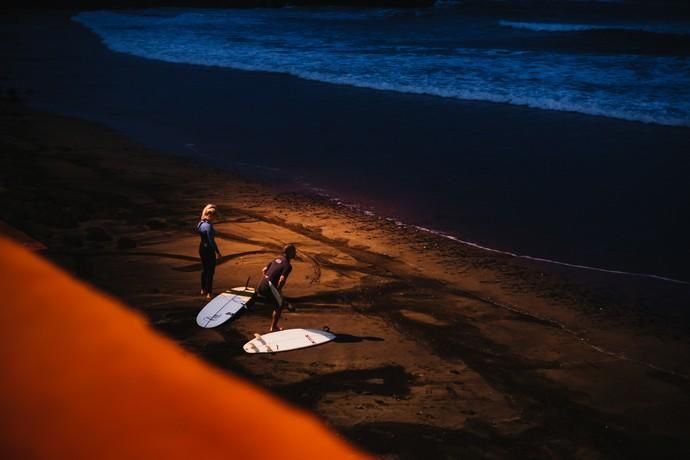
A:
63;2;690;284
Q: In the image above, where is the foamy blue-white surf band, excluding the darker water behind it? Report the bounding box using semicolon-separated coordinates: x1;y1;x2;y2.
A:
75;9;690;126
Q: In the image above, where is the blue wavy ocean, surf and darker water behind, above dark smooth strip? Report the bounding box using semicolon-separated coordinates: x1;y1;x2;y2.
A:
75;6;690;126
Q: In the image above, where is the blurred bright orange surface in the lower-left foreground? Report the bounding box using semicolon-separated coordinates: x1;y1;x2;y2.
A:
0;238;365;460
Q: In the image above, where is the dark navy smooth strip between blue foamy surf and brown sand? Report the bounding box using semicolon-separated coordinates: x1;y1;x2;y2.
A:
5;8;690;280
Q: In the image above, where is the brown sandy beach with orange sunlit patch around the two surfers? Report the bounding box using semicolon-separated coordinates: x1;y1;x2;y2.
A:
0;8;690;459
